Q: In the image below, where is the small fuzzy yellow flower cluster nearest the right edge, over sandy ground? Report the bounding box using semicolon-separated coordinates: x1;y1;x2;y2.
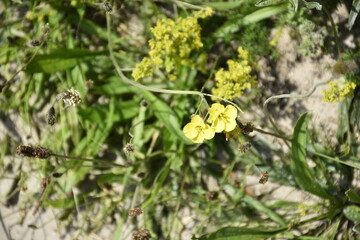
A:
323;77;356;103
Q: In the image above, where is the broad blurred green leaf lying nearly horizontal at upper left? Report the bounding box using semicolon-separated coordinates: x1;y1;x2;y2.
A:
26;49;106;73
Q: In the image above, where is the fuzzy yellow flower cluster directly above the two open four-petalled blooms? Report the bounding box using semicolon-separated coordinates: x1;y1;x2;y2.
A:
212;47;256;100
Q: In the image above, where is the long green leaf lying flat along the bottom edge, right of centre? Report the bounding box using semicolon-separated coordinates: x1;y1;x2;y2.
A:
198;227;287;240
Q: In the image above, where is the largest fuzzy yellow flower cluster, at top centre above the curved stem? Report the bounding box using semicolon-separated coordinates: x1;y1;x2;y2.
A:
132;8;213;81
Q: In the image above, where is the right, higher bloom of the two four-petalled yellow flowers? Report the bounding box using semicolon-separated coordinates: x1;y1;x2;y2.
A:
208;103;237;132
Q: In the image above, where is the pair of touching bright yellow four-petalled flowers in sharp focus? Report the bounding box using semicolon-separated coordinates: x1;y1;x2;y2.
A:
183;103;238;143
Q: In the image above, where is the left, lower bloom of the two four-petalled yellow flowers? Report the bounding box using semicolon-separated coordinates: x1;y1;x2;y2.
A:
183;115;215;143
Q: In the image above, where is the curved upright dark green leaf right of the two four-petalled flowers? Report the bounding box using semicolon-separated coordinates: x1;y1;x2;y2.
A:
290;113;332;199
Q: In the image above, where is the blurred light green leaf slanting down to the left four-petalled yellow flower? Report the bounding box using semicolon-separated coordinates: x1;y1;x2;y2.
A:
139;89;193;144
